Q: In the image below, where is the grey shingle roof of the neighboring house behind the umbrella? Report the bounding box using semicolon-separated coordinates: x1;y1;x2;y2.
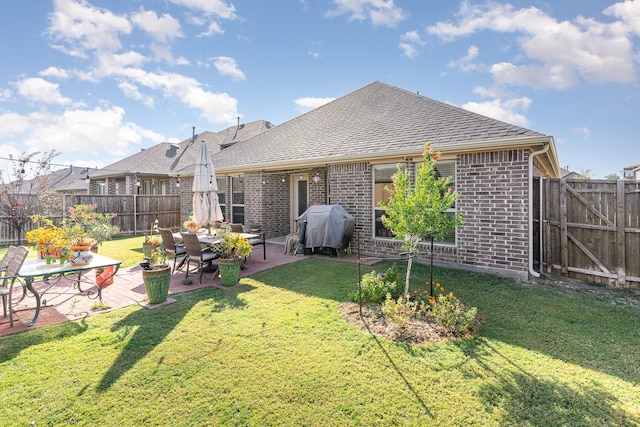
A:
91;120;273;178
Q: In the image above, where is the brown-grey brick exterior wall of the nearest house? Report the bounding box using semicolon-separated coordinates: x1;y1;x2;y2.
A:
171;150;529;278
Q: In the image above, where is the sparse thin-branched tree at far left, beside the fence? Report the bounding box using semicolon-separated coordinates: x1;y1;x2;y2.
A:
0;151;62;245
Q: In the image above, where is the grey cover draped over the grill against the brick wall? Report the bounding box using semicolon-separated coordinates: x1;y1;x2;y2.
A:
298;205;356;249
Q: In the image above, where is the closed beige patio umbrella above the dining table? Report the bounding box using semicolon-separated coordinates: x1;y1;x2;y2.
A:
192;141;224;225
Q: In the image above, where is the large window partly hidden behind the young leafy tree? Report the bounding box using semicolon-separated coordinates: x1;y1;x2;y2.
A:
373;160;456;244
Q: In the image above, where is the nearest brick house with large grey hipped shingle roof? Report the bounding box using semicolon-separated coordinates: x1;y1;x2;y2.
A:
188;82;560;279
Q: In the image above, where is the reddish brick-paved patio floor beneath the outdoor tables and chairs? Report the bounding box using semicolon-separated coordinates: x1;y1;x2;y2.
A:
0;239;304;336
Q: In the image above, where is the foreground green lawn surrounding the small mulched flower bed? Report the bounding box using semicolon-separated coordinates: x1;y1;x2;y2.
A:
0;256;640;426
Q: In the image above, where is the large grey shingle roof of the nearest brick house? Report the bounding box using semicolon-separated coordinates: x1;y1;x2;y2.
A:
212;82;559;176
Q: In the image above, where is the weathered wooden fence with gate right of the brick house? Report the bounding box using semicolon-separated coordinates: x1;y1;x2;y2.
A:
533;178;640;289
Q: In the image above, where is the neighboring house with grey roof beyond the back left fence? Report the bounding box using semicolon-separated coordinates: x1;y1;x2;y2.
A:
85;120;273;195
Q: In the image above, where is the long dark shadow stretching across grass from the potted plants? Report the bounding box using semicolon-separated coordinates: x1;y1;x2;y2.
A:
96;284;254;391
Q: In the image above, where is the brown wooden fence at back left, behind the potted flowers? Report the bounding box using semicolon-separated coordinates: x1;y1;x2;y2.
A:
0;194;181;245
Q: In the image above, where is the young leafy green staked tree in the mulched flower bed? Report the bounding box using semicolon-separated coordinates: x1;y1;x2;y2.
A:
380;143;463;301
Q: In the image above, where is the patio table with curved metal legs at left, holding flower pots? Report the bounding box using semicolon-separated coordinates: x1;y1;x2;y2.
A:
18;254;122;326
